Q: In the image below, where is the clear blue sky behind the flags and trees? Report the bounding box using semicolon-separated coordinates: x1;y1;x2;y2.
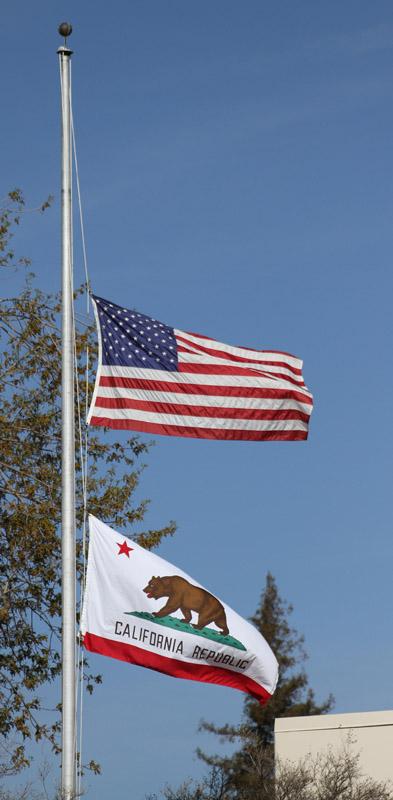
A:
1;0;393;800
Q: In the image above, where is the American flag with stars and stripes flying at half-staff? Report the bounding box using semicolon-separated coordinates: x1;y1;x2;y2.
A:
87;297;312;441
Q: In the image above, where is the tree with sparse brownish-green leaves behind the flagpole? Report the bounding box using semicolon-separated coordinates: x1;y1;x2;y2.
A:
0;191;175;769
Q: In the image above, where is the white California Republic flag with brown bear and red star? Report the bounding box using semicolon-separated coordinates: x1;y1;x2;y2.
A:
81;516;278;704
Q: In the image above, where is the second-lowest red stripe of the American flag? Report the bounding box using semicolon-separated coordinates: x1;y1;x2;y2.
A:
95;396;310;422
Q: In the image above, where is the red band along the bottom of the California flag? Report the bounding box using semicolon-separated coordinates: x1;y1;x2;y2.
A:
83;633;271;705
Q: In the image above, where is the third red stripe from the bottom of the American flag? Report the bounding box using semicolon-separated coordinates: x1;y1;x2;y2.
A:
100;370;313;406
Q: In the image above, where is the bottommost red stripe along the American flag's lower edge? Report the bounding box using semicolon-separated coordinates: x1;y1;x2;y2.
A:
90;416;308;442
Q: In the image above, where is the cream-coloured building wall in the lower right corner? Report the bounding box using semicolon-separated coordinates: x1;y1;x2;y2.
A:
275;711;393;781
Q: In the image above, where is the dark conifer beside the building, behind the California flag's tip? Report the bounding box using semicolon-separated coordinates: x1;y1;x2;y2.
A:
198;572;333;798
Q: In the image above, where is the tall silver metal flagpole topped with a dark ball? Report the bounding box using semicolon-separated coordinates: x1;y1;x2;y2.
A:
57;22;76;800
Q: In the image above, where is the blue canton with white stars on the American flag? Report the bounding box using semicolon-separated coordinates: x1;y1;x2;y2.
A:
94;295;178;372
